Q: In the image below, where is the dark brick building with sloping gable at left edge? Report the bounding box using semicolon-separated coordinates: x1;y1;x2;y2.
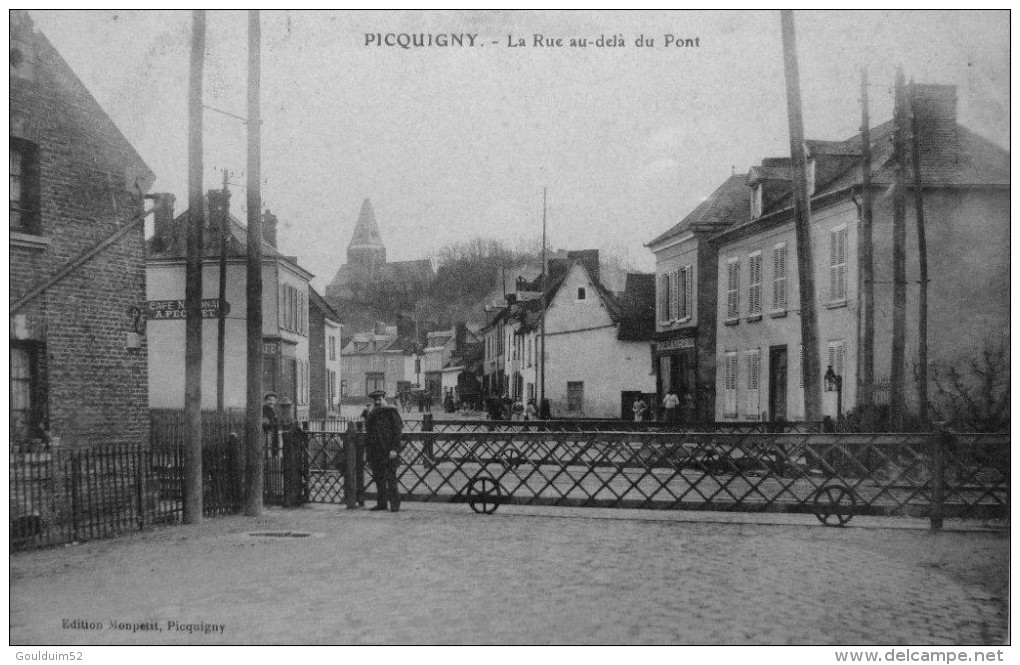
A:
8;11;154;445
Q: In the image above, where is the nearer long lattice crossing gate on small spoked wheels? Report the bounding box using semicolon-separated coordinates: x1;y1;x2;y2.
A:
297;427;1010;524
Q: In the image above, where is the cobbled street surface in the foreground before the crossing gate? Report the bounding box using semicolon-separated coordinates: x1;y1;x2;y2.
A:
10;503;1009;645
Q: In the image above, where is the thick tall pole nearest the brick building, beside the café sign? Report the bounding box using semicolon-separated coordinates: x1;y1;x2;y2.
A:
184;9;205;524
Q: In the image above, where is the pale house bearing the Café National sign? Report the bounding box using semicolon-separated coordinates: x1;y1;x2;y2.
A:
145;198;313;420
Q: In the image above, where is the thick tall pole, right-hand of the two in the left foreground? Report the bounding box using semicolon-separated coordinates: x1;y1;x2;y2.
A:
245;9;265;516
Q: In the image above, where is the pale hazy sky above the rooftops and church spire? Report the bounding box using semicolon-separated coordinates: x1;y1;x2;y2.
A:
32;10;1010;290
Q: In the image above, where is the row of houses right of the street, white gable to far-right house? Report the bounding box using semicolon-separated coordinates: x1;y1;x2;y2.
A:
482;85;1010;421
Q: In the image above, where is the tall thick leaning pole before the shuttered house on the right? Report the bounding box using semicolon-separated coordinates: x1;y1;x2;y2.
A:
780;9;822;420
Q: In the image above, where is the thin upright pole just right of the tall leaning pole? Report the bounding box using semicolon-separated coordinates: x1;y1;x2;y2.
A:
857;67;875;406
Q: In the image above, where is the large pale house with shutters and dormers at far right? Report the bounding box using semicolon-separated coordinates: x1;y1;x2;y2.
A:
713;85;1010;420
